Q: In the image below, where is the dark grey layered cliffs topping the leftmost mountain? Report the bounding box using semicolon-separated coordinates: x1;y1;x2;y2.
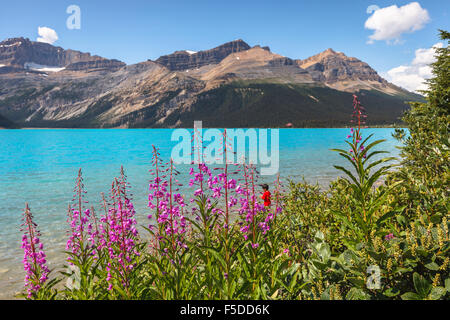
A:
0;38;125;70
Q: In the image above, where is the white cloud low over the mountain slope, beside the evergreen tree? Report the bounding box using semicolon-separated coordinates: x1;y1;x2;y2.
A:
384;42;444;92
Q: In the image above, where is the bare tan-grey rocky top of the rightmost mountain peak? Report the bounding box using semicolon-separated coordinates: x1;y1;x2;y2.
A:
296;49;386;83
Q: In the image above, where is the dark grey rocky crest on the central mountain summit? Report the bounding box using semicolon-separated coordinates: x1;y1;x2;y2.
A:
156;40;250;71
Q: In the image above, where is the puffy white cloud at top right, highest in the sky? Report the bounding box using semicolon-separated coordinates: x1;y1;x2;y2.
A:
364;2;430;43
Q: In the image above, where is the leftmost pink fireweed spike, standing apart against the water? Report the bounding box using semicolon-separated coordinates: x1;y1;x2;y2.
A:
21;203;50;298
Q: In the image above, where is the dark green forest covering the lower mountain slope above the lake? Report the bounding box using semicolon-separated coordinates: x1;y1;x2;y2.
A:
166;81;422;128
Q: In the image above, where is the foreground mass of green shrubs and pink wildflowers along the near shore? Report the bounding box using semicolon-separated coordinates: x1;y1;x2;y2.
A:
17;31;450;299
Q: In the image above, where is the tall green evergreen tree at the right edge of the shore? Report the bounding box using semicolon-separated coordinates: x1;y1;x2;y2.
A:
393;30;450;220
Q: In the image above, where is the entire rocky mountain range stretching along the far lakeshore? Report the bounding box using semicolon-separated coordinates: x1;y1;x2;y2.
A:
0;38;423;128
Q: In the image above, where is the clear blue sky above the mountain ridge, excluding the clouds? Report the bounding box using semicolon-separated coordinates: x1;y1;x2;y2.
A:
0;0;450;89
